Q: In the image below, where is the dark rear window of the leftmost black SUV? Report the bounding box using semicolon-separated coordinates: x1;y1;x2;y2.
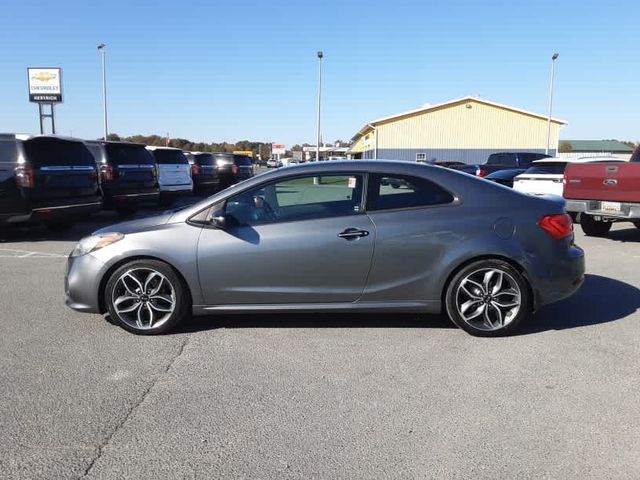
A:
24;138;95;166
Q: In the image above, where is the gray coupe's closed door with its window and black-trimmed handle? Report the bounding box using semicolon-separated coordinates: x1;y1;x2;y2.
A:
198;173;375;305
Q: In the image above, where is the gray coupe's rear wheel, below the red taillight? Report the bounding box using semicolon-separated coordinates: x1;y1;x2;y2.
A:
445;259;533;337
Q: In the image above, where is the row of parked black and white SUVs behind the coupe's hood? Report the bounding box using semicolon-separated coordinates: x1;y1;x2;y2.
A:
0;134;253;229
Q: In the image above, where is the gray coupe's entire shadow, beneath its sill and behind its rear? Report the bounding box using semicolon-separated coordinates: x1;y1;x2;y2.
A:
179;275;640;335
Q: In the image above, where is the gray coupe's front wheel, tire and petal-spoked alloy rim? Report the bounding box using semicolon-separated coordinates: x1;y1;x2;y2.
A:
104;260;190;335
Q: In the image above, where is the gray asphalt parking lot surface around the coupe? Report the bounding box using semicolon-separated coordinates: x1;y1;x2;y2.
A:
0;197;640;479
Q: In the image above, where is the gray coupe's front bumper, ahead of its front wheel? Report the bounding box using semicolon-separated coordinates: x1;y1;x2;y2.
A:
64;253;106;313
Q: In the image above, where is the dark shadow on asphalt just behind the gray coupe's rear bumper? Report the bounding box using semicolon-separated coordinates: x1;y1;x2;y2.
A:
516;274;640;335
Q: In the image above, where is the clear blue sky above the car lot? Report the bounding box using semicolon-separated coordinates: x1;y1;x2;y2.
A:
0;0;640;146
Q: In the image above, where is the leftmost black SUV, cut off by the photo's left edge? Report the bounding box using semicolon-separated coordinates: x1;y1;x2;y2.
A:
0;134;102;229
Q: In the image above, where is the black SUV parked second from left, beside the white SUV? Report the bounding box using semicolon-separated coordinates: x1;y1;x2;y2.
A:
85;140;160;214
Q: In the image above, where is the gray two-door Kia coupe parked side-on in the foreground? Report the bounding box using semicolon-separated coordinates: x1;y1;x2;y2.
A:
65;160;584;336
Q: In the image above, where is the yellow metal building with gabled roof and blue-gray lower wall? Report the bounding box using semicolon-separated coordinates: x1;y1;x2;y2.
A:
349;97;567;163
